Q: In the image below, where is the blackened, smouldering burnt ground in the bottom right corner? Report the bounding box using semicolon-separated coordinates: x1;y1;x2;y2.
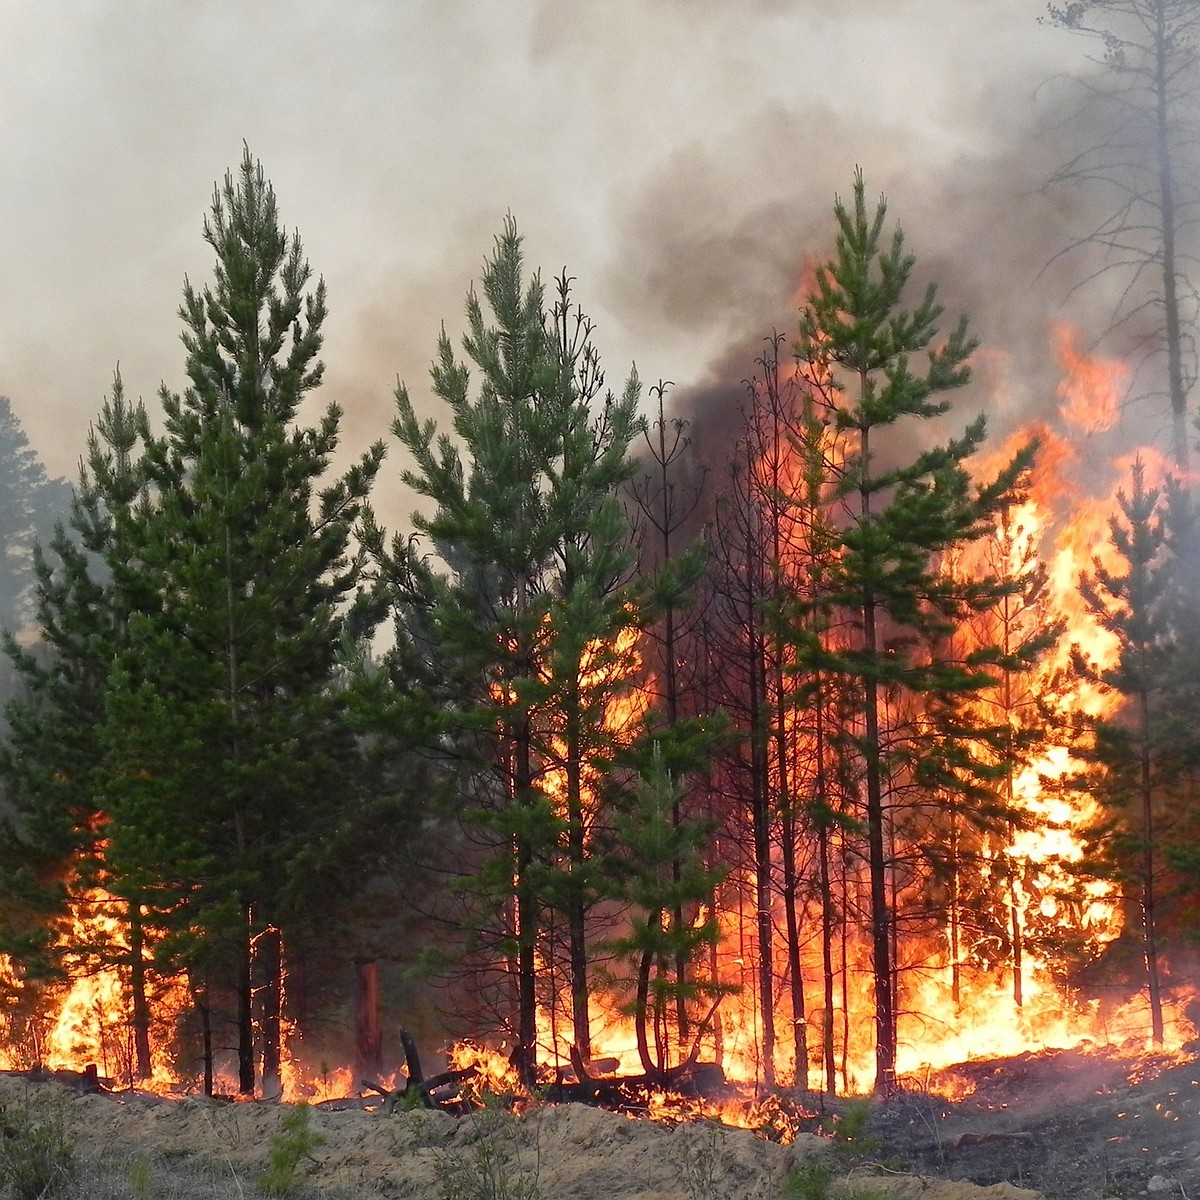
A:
859;1046;1200;1200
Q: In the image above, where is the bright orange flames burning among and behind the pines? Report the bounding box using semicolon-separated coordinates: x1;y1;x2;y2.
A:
0;325;1195;1123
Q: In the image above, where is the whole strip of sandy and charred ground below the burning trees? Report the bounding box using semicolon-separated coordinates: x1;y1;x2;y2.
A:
0;1051;1200;1200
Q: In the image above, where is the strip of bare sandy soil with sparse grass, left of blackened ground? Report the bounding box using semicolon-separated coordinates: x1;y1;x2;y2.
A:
0;1076;1037;1200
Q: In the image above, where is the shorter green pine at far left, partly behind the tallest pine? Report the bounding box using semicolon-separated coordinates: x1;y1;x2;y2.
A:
0;374;157;1078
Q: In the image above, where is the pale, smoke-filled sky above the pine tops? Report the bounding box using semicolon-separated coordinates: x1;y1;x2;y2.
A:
0;0;1123;527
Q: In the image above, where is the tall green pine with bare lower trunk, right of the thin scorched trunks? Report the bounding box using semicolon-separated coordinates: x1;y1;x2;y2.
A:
798;173;1032;1092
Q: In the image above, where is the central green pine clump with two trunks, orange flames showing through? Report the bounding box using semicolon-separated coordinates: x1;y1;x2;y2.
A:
374;220;641;1079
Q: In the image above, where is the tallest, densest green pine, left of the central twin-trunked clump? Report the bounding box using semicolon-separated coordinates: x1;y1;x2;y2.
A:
108;150;383;1093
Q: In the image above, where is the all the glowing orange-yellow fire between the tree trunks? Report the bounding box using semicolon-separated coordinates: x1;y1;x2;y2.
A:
5;314;1194;1118
